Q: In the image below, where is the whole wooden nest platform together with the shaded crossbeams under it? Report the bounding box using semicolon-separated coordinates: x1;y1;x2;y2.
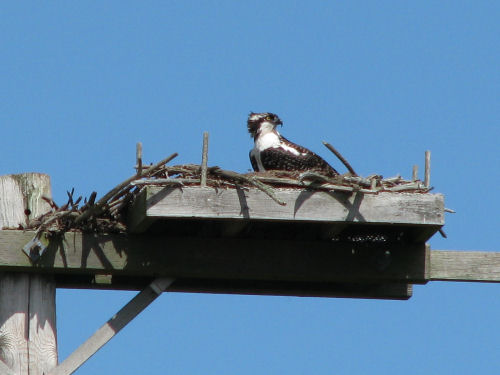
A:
0;186;450;299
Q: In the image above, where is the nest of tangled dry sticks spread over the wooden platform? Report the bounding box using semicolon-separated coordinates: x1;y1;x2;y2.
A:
23;154;430;234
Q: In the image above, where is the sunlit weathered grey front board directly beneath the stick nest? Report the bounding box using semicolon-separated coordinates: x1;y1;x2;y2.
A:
129;186;444;232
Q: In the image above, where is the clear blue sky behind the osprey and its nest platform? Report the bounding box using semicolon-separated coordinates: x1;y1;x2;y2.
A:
0;0;500;375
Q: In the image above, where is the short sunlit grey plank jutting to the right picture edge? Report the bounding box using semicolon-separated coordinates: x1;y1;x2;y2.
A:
430;250;500;282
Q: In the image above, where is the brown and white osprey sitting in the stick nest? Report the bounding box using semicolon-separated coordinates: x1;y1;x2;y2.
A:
247;112;338;176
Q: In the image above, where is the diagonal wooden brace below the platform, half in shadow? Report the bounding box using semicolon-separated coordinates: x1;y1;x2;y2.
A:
48;278;173;375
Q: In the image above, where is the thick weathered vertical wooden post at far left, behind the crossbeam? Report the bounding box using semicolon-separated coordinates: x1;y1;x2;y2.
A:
0;173;57;375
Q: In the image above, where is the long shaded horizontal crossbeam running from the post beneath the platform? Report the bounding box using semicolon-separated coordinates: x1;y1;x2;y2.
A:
0;231;427;284
